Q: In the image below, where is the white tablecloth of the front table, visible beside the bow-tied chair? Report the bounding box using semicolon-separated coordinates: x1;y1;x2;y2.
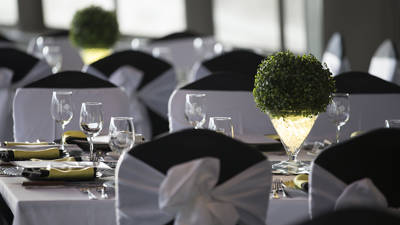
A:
0;147;310;225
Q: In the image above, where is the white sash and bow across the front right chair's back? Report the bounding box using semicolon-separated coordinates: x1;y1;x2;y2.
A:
309;163;394;218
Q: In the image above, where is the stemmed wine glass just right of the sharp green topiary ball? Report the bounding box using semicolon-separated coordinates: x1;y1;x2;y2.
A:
326;93;350;143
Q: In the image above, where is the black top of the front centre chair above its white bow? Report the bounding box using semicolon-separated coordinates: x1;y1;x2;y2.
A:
129;129;265;184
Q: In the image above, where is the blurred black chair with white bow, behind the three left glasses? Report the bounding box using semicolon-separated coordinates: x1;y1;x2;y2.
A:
84;50;177;140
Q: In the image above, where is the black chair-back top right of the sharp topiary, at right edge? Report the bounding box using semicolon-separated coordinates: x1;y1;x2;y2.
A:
334;71;400;94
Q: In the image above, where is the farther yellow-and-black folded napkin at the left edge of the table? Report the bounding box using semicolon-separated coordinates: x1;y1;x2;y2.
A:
0;148;62;162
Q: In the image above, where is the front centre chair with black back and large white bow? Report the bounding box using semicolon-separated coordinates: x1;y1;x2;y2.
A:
116;129;272;225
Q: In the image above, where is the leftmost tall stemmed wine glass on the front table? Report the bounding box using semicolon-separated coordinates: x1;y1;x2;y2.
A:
51;91;74;150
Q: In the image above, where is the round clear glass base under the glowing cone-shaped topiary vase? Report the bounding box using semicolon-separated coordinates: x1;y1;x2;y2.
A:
272;160;311;175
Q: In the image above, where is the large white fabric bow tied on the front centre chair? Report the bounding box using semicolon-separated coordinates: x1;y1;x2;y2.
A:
159;158;239;225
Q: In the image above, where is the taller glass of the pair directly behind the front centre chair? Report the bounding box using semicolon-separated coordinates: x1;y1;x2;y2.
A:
185;94;206;129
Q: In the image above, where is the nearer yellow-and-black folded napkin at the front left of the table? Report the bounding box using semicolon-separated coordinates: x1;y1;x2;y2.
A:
22;167;96;181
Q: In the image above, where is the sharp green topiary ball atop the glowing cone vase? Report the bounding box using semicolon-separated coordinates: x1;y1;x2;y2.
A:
253;51;335;117
